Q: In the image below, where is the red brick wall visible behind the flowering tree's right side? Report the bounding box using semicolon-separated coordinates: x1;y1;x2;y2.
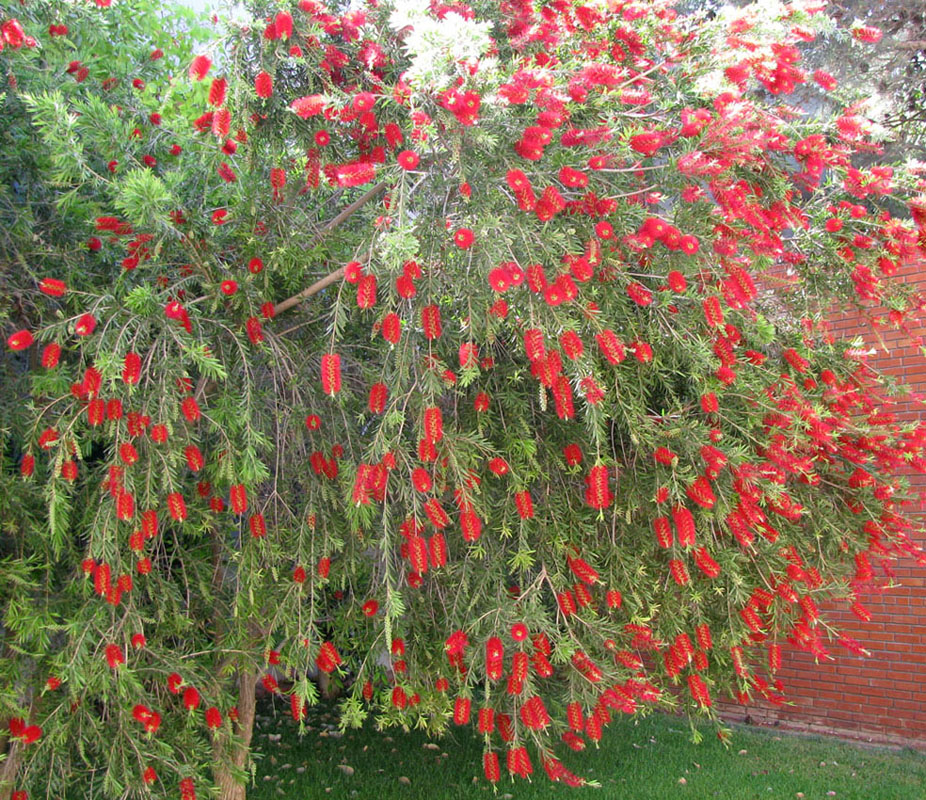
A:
723;263;926;750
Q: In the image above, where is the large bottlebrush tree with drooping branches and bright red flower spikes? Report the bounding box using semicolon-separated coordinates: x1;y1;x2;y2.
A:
0;0;926;800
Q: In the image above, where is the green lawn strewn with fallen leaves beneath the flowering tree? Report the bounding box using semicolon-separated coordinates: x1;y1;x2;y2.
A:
249;704;926;800
